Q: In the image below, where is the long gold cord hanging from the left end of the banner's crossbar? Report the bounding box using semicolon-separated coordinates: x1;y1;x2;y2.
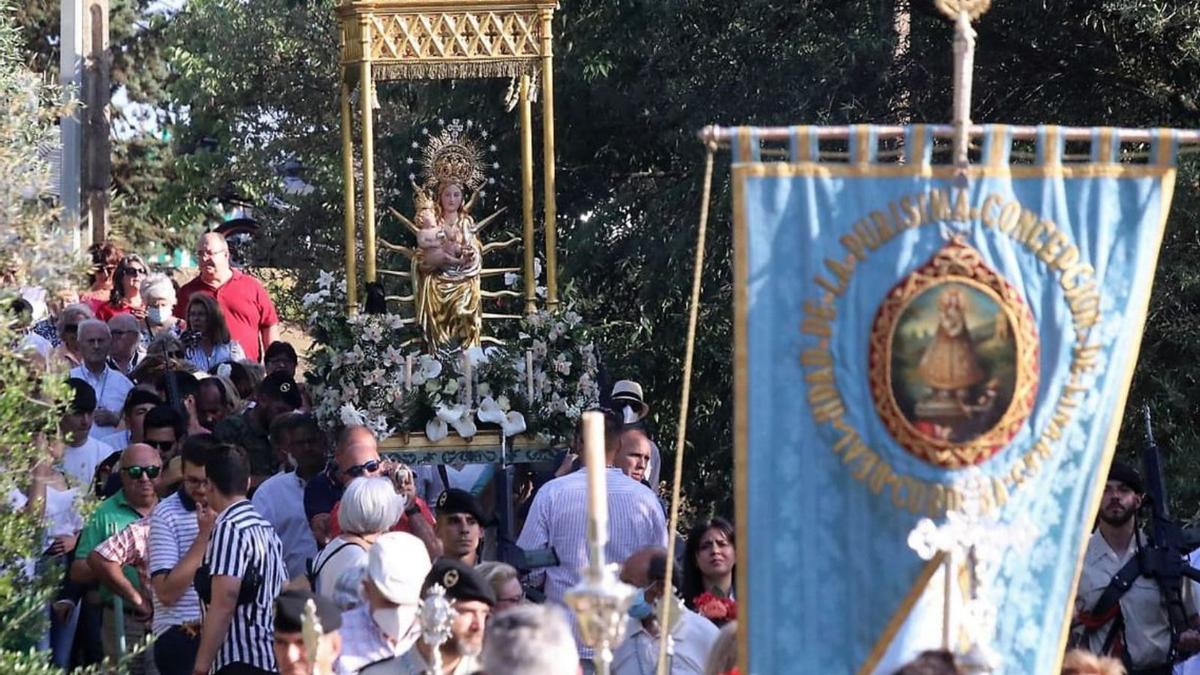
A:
658;143;716;675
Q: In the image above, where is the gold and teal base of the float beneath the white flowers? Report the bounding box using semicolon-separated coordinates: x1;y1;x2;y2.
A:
379;429;556;466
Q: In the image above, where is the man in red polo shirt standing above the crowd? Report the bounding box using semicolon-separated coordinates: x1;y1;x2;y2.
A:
175;232;280;362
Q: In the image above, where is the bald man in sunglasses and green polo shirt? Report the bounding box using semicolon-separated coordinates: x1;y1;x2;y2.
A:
71;443;162;674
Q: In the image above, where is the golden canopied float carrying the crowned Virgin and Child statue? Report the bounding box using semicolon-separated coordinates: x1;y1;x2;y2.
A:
326;0;577;464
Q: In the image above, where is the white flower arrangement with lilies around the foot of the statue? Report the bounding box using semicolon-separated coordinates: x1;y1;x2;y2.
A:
302;271;600;443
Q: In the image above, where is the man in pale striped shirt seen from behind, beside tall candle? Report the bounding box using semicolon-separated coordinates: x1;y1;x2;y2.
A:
517;403;667;665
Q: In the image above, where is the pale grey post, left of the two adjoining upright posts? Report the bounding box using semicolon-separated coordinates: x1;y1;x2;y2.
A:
59;0;82;252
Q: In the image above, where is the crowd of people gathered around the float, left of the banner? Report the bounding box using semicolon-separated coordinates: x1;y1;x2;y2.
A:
10;228;737;675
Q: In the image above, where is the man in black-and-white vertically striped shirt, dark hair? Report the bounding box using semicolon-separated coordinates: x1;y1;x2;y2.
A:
193;446;287;675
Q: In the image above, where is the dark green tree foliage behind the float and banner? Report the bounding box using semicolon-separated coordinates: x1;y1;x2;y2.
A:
18;0;1200;513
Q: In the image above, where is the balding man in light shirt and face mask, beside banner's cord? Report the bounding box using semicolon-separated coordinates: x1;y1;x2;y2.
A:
612;548;720;675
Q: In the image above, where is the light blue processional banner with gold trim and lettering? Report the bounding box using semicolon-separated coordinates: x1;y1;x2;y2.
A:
733;126;1177;675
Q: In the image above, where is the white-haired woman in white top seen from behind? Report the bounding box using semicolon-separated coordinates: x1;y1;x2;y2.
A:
310;476;404;599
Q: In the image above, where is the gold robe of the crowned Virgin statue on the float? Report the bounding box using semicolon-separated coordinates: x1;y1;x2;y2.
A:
413;214;484;352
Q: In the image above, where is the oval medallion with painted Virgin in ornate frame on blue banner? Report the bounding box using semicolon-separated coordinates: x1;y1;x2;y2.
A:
871;241;1038;467
